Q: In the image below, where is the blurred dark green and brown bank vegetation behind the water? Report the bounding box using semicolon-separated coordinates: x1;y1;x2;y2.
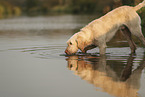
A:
0;0;145;30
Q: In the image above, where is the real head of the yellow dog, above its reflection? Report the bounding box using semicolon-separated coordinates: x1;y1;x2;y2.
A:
65;33;84;55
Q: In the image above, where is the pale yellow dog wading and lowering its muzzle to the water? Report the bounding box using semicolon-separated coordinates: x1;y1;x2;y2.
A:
65;0;145;55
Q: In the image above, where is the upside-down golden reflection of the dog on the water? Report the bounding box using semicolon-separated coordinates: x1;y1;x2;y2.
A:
66;55;145;97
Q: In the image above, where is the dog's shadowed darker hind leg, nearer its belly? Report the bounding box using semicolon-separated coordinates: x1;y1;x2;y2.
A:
121;25;136;53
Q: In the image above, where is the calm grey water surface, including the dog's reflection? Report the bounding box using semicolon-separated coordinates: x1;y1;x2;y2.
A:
0;15;145;97
